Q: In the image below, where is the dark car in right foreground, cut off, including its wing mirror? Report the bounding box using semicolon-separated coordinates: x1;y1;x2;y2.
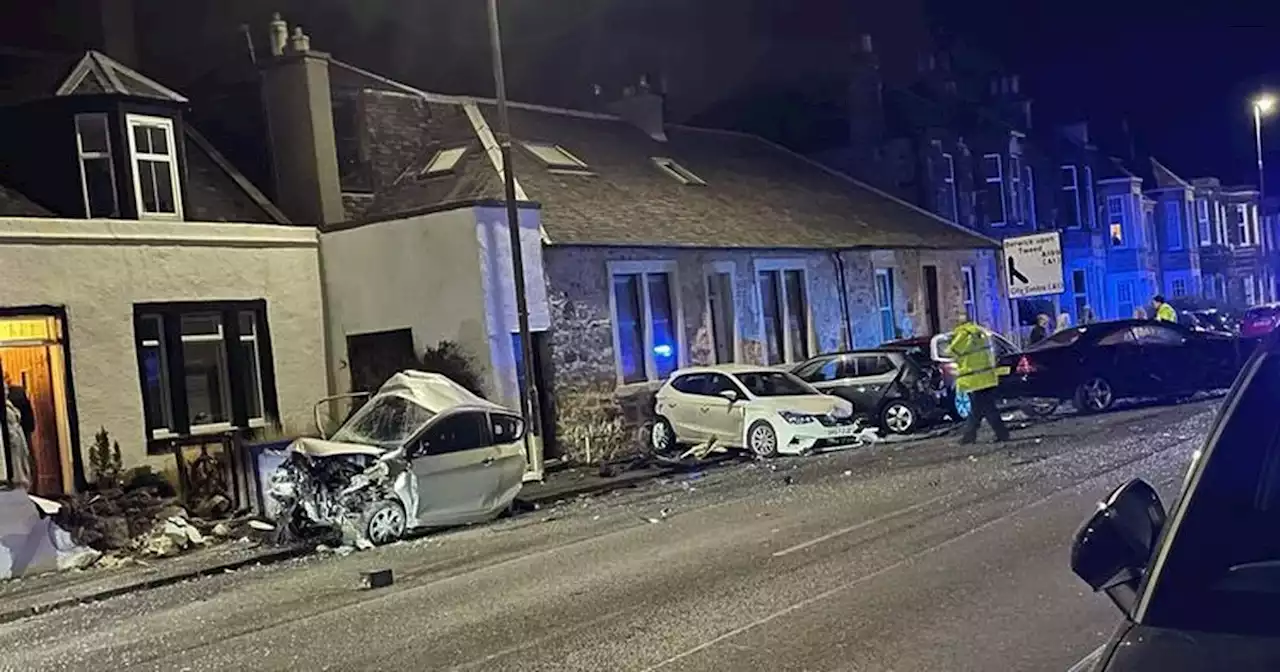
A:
1071;327;1280;672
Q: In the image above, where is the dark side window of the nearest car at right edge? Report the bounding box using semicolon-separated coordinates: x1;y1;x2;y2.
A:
1144;355;1280;634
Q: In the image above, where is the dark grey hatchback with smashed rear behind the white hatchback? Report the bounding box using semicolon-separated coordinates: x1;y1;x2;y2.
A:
792;346;951;434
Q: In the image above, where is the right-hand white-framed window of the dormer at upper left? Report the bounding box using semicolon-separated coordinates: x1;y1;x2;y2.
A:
125;114;182;219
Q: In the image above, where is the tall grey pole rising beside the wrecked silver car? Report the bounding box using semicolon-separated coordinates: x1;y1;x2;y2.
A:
489;0;543;474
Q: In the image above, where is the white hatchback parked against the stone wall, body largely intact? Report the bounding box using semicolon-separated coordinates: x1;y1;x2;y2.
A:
652;365;861;457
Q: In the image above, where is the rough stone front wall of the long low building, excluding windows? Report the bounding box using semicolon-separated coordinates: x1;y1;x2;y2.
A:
543;246;1001;458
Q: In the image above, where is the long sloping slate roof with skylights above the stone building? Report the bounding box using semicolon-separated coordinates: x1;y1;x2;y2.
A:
480;104;997;248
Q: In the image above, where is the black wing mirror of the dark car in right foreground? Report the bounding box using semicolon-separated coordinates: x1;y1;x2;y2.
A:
1071;479;1165;616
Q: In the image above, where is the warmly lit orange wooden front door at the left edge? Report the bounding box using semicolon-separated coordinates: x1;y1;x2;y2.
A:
0;344;63;494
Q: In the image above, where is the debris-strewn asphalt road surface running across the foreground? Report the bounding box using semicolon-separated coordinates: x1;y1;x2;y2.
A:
0;401;1217;672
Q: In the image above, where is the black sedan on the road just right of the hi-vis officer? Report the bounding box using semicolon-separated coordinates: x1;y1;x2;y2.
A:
1000;320;1248;413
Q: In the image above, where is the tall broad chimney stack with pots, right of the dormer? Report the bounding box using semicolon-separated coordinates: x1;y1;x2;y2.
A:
262;14;346;227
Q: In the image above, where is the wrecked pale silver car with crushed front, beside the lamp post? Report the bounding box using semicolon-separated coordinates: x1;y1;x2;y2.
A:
269;371;525;544
